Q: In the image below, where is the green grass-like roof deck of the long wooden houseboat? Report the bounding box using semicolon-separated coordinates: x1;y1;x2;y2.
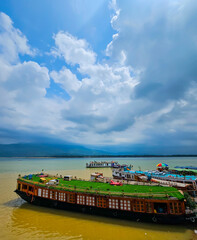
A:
20;175;184;200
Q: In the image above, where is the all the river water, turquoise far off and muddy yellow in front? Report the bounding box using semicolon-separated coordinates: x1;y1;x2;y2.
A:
0;158;197;240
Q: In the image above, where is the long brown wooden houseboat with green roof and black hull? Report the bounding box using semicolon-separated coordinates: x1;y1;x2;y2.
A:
15;174;196;224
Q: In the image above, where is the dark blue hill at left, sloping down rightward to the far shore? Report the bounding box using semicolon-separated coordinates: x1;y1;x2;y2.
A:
0;143;107;157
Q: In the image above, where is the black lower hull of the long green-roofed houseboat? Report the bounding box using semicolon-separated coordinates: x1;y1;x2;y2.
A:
15;190;191;224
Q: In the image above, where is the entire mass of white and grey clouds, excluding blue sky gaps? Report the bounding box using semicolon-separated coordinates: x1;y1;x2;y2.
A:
0;5;197;150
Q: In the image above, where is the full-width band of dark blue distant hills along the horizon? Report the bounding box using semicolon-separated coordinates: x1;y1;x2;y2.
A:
0;142;197;157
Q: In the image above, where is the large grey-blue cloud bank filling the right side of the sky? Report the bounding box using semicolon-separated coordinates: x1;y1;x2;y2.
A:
98;0;197;144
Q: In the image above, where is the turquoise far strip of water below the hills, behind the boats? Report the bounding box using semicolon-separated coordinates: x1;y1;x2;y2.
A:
0;157;197;173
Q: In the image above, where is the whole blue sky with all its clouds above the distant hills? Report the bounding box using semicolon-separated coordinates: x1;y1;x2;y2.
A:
0;0;197;153
